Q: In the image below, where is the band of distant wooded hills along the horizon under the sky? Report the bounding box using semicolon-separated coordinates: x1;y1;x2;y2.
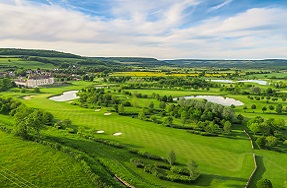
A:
0;48;287;70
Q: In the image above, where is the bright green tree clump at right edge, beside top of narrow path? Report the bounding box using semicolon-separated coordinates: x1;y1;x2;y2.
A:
247;116;287;149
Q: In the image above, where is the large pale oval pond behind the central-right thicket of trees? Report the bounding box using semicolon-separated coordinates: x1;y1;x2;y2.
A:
175;95;244;106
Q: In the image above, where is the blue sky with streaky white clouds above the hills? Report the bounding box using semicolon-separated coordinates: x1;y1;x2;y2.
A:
0;0;287;59
